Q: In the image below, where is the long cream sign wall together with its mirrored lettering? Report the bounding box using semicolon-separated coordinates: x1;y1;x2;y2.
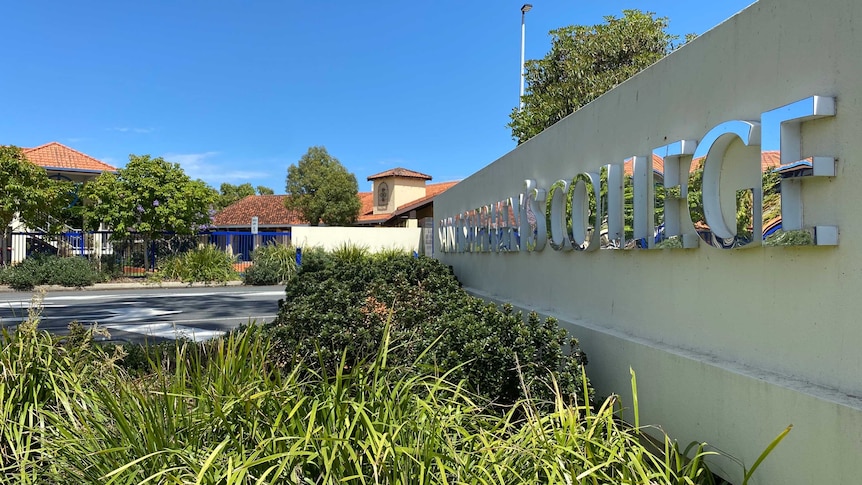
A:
434;0;862;484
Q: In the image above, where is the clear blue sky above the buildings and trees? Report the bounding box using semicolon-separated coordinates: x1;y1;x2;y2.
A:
0;0;752;193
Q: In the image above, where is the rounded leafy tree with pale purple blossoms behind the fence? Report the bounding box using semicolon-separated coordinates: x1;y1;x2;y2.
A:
83;155;218;264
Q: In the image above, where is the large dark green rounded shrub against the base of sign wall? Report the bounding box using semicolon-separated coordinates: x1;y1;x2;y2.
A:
267;254;586;406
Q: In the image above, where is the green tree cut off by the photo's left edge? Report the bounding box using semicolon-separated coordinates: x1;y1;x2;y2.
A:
0;145;72;264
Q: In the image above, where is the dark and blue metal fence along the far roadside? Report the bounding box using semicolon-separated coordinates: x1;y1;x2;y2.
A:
7;231;291;276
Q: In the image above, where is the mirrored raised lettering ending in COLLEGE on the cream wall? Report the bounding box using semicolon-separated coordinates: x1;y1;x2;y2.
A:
437;96;838;253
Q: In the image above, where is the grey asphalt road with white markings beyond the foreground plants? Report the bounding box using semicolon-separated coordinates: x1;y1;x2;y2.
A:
0;286;284;342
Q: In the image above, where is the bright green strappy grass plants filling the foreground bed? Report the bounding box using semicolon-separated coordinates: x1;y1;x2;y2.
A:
0;300;786;485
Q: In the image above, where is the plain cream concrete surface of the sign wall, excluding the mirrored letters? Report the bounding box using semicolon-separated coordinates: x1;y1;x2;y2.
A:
434;0;862;484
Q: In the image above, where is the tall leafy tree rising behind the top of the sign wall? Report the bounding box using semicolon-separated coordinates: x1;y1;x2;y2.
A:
508;10;689;144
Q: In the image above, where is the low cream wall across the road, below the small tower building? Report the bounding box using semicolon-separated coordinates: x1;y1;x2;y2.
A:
291;226;422;252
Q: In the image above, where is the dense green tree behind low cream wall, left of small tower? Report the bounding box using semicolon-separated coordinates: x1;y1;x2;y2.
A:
285;146;361;226
